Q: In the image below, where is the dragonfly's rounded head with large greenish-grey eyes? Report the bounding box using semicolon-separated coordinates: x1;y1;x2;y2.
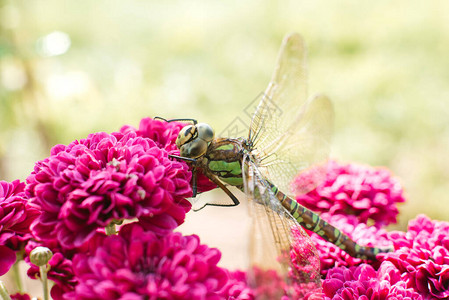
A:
176;123;214;158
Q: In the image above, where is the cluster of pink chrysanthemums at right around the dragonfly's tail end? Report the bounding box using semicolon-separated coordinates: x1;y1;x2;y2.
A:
306;162;449;299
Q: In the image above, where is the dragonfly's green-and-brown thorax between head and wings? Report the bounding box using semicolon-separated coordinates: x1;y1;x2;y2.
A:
204;138;246;187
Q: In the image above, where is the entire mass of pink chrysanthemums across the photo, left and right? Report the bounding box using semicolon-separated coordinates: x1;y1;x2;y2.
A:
0;118;449;300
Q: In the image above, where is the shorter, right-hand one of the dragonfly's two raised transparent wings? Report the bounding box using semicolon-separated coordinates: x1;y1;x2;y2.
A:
254;96;333;196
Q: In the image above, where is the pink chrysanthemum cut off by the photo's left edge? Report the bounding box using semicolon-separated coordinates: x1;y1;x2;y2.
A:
0;180;39;275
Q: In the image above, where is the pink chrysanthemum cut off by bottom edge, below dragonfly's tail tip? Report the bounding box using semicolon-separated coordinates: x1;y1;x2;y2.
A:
323;263;423;300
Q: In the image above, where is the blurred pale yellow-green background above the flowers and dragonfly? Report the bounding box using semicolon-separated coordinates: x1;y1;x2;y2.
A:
0;0;449;233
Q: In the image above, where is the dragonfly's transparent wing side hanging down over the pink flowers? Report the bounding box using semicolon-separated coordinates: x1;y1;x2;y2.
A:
244;161;321;299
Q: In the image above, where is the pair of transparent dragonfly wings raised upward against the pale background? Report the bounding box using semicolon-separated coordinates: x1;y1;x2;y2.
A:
249;34;334;196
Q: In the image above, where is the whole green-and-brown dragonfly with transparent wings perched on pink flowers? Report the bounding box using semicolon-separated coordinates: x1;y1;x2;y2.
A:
160;33;388;298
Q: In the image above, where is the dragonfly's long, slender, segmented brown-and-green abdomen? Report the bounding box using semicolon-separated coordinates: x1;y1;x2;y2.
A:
270;184;391;260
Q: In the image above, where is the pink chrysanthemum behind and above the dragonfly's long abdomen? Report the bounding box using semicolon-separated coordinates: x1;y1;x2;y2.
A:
295;161;405;227
